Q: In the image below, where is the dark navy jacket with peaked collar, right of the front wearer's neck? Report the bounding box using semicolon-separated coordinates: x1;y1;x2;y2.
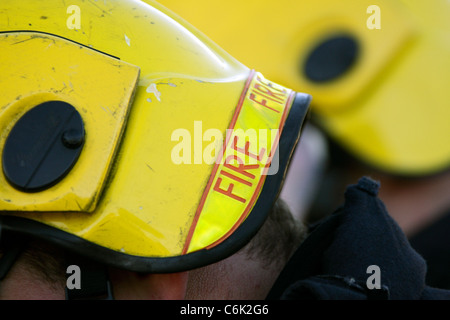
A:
267;177;450;300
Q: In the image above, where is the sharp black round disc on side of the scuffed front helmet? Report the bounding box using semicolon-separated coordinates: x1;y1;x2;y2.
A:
2;101;85;192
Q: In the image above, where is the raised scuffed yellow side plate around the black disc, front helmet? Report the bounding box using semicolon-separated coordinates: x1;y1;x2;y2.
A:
0;32;139;212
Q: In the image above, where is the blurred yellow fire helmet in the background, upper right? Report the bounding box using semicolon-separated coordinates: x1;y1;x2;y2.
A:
161;0;450;176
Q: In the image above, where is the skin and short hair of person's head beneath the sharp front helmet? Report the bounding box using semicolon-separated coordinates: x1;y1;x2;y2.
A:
0;199;306;300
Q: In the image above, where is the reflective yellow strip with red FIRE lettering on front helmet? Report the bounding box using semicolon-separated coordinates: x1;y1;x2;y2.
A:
183;72;294;253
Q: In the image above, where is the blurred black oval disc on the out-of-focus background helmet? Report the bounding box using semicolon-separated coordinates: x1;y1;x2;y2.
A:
303;35;359;82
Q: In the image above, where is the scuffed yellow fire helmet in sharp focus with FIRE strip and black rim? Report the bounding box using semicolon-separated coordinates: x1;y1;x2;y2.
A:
0;0;310;273
